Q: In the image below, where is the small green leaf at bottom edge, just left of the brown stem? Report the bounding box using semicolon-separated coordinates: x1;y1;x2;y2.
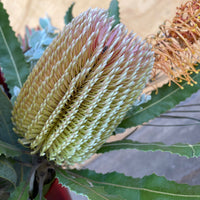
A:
9;181;29;200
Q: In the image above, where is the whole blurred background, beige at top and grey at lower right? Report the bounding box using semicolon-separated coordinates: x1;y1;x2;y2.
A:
2;0;200;200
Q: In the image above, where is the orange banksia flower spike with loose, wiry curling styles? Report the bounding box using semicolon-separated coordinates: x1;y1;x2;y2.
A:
148;0;200;88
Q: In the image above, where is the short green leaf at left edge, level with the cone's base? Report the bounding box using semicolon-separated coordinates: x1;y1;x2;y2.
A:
0;140;22;157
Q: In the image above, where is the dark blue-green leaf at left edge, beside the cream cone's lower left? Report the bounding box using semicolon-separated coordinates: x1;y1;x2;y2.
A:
0;88;18;144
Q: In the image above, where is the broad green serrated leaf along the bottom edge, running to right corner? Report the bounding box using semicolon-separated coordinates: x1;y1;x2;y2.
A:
57;169;200;200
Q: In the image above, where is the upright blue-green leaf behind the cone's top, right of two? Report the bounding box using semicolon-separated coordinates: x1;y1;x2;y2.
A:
108;0;120;27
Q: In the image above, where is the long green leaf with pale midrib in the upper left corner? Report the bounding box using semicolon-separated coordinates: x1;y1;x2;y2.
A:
0;2;29;95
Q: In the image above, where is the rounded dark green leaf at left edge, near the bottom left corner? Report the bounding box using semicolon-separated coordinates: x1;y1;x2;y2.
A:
0;159;17;186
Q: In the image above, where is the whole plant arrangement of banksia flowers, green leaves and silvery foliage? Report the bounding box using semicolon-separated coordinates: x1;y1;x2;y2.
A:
0;0;200;200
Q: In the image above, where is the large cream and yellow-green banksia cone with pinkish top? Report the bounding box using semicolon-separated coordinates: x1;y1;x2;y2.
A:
12;9;154;165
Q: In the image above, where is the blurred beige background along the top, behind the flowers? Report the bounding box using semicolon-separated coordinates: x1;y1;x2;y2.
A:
1;0;185;37
